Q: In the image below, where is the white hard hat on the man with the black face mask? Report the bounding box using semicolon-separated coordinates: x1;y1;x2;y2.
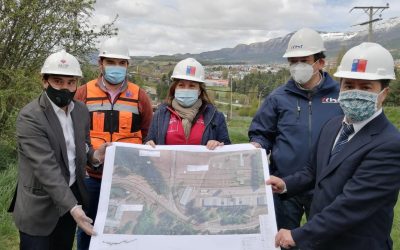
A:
40;50;82;77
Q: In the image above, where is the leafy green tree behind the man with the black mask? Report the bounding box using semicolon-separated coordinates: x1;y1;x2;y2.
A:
0;0;118;144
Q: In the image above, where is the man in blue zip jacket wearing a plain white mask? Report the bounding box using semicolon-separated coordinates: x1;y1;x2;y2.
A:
249;28;342;242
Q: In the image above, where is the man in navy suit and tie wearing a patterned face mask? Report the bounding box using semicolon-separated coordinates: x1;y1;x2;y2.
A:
266;43;400;250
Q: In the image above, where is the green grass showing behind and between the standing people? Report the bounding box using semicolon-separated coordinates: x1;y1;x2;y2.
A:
0;107;400;250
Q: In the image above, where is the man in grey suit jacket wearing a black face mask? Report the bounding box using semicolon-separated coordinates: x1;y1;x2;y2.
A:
10;51;107;250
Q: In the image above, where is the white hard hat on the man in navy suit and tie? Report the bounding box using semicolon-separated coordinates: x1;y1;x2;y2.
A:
334;43;396;80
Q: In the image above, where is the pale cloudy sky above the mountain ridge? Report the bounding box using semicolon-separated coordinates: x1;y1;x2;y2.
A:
92;0;400;56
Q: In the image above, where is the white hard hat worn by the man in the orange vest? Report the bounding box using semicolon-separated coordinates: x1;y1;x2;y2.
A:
99;37;131;60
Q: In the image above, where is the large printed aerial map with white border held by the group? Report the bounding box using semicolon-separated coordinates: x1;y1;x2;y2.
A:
90;143;276;250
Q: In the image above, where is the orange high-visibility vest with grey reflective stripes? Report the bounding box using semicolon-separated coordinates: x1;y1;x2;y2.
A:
86;79;142;149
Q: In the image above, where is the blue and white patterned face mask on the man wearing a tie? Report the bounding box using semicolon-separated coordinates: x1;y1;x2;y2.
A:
338;89;383;122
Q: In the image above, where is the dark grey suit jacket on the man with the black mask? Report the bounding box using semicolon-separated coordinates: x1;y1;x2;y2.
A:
13;93;93;236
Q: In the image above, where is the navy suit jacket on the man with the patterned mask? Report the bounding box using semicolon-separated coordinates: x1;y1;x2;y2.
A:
284;113;400;250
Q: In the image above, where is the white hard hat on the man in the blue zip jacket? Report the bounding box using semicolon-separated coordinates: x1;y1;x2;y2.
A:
283;28;325;57
